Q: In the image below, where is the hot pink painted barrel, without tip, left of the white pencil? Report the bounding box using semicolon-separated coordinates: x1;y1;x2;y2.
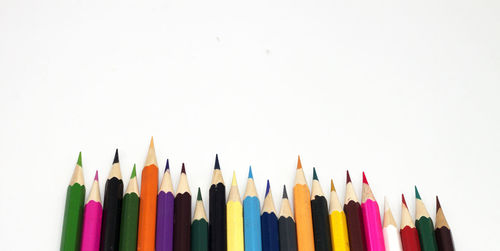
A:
361;199;385;251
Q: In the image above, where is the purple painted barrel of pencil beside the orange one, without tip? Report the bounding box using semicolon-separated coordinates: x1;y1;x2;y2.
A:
156;191;174;251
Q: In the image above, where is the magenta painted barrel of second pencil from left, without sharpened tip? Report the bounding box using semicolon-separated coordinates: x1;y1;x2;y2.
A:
81;200;102;251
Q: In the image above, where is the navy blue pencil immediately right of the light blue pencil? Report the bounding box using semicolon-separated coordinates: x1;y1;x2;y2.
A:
260;180;280;251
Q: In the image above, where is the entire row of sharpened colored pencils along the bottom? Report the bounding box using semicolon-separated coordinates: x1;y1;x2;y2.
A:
61;140;454;251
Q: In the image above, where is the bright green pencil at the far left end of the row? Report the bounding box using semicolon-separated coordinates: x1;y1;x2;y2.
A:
61;152;85;251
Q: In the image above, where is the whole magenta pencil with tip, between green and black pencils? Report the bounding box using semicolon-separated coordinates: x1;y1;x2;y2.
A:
81;171;102;251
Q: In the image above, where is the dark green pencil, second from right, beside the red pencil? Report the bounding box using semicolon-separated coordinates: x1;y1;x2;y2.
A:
415;186;438;251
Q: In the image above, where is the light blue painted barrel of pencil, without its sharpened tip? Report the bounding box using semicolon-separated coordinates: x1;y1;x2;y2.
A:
243;196;262;251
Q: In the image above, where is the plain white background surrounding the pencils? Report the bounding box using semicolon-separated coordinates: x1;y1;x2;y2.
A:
0;0;500;250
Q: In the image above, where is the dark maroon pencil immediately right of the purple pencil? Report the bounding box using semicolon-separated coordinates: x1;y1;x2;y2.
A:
173;163;191;251
